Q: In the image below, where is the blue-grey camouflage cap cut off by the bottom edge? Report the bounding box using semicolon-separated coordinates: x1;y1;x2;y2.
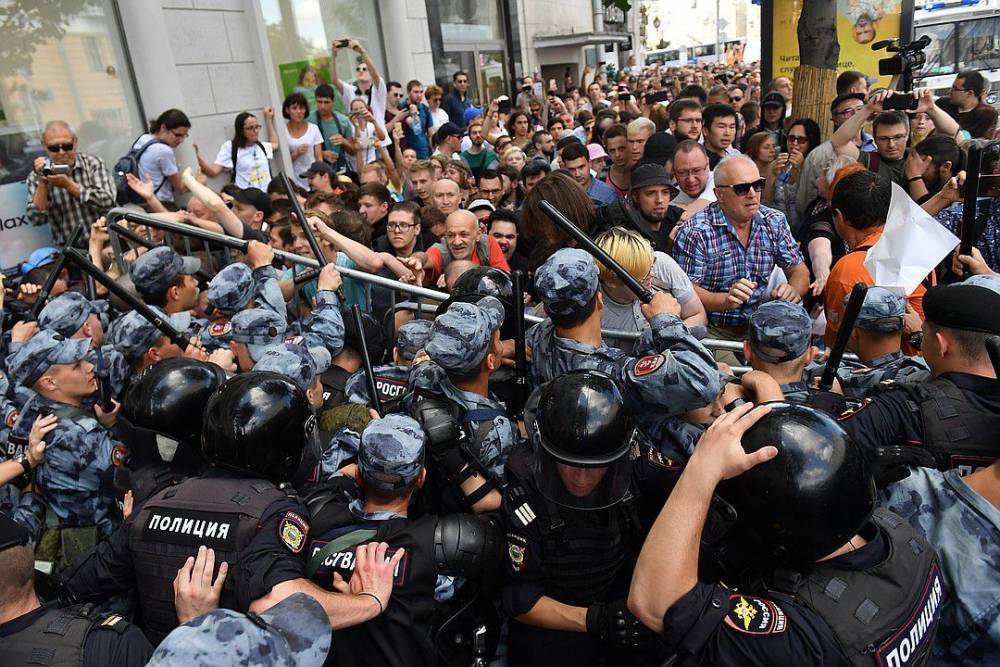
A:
147;593;331;667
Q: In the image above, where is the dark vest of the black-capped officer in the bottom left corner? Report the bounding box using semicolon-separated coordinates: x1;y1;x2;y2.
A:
0;604;122;667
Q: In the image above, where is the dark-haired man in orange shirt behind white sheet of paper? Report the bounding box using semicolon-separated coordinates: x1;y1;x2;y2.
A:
823;171;927;354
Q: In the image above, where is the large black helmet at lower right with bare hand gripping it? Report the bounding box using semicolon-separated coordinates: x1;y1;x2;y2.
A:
716;403;875;569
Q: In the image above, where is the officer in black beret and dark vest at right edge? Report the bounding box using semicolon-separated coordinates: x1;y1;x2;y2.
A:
840;283;1000;472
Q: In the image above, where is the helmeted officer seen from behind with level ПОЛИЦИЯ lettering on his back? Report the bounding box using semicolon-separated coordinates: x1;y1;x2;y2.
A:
62;371;402;641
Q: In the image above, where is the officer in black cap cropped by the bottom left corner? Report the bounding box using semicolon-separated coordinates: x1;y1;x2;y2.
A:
0;514;153;667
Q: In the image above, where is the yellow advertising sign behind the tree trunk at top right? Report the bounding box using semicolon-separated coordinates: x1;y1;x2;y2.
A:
771;0;903;88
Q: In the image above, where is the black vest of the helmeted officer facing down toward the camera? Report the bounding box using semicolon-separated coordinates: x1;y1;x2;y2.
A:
504;448;638;607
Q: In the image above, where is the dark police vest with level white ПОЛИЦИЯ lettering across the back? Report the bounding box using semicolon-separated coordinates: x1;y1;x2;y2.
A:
129;477;286;645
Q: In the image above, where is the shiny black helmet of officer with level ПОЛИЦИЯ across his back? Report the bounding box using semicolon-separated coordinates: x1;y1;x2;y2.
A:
202;371;316;483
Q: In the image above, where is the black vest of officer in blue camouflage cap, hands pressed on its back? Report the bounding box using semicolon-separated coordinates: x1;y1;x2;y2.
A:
306;503;438;667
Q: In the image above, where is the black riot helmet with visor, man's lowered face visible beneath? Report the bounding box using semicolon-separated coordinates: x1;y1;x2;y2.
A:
525;369;637;510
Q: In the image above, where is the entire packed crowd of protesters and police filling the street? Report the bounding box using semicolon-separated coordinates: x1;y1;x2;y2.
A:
0;40;1000;666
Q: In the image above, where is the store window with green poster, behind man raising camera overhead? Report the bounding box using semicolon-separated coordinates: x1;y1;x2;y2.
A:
260;0;385;110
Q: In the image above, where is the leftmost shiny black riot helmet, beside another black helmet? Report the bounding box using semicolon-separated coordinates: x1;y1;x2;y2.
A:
118;357;226;471
